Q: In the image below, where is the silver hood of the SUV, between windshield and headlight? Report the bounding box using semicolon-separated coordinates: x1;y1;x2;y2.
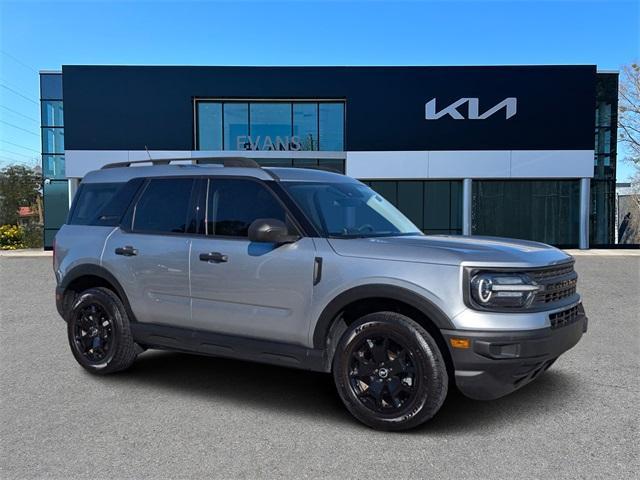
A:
329;235;571;267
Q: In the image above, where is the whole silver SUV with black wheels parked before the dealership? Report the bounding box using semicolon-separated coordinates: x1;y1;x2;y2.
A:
54;158;587;430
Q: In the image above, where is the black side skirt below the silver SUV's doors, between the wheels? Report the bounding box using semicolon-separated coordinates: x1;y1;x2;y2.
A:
131;322;330;372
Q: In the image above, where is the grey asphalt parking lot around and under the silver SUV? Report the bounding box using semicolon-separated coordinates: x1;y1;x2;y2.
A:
0;256;640;480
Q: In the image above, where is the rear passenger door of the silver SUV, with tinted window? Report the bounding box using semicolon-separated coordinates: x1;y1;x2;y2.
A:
102;177;199;326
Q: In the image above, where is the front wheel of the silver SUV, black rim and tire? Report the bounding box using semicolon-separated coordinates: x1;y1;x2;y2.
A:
333;312;449;431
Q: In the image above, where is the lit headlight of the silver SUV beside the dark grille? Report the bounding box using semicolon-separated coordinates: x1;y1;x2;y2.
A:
471;273;542;308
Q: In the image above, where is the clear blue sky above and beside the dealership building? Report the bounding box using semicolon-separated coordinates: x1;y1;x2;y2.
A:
0;0;640;181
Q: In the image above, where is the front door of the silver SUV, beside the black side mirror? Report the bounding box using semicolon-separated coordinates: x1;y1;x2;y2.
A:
190;178;315;344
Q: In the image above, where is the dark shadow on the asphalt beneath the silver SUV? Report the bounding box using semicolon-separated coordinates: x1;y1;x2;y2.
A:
105;351;577;434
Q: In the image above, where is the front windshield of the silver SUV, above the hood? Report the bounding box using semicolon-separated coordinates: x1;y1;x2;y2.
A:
282;182;422;238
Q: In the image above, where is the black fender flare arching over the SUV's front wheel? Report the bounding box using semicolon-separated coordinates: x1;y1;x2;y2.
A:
313;284;455;349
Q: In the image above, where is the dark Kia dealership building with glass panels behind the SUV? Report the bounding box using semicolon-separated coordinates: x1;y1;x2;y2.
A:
40;65;618;248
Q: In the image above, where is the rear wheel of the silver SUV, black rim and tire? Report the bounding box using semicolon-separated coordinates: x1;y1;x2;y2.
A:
67;288;139;375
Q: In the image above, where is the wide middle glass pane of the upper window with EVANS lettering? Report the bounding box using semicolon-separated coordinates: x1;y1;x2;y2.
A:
249;103;297;150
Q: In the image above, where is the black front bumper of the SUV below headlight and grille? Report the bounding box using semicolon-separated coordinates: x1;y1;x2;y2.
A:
442;304;588;400
